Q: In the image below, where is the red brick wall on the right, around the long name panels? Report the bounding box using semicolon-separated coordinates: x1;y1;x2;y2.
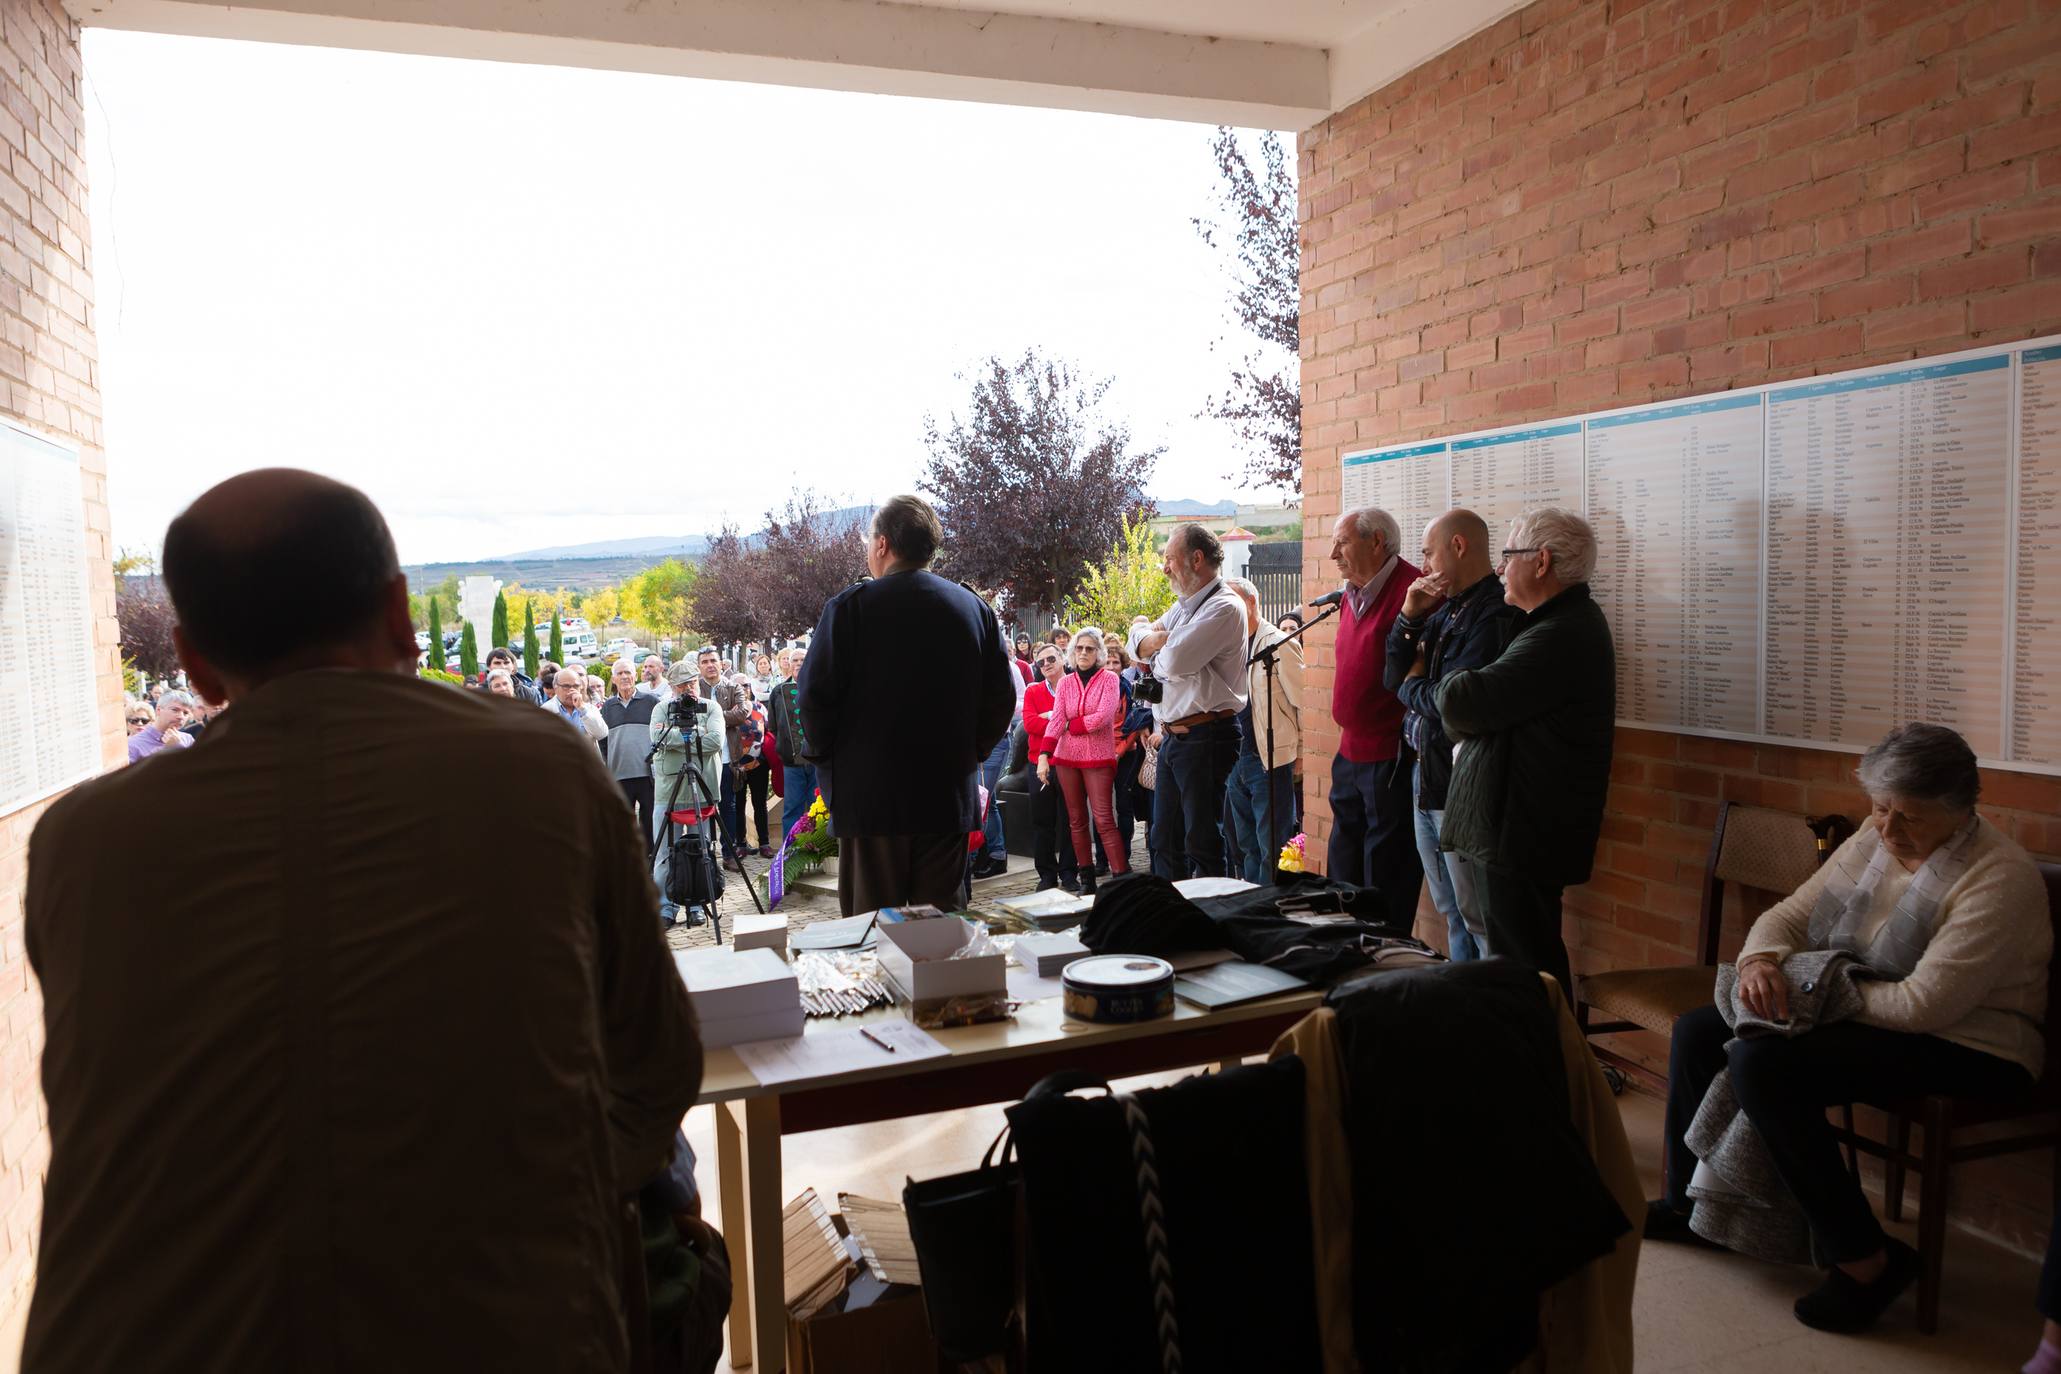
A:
1300;0;2061;1246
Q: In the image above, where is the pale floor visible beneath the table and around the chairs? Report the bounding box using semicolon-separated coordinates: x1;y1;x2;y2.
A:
688;1094;2040;1374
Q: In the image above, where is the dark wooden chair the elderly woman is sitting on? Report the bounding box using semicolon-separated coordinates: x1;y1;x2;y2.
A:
1832;863;2061;1335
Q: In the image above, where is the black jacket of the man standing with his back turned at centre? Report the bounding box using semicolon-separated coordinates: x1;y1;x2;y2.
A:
802;569;1016;836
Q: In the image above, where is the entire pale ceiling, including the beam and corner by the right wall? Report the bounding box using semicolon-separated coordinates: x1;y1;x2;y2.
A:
64;0;1523;130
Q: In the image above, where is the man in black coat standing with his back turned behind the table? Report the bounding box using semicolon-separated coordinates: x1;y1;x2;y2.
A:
800;496;1016;917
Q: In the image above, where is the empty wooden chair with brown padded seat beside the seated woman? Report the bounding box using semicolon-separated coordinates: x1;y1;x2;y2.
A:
1575;801;1853;1094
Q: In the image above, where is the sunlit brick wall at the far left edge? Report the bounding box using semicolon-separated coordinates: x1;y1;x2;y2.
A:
0;0;108;1316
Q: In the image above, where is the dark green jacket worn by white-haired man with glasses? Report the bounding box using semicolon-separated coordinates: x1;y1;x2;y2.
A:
1439;583;1618;886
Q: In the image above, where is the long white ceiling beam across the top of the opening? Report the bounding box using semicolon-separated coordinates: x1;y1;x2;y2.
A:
66;0;1335;130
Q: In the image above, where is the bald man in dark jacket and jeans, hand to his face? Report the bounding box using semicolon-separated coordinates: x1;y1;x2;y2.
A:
1381;511;1523;960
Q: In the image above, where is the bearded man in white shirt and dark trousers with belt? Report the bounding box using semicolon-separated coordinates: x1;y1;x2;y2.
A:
1129;525;1247;880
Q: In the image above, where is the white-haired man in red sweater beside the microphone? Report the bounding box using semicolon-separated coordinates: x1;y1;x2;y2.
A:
1325;507;1424;931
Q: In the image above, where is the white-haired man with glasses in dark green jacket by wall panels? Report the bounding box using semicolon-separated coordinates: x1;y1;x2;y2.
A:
1437;507;1618;999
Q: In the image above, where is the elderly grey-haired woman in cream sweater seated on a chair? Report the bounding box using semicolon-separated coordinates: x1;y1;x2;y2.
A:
1645;725;2053;1331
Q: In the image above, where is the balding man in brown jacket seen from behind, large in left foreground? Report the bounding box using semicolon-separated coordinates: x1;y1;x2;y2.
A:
21;470;701;1374
